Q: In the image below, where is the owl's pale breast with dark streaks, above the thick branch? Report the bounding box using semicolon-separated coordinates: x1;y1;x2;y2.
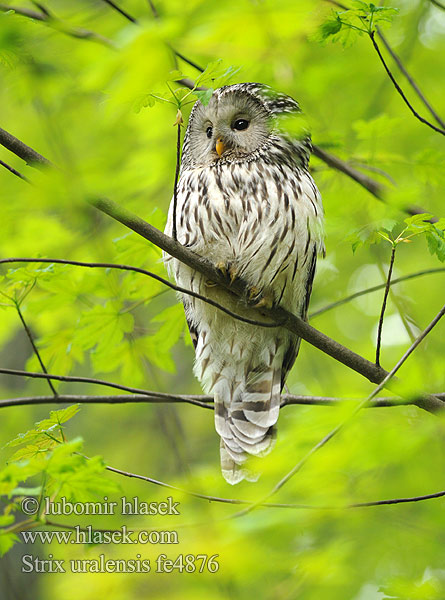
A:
170;161;322;312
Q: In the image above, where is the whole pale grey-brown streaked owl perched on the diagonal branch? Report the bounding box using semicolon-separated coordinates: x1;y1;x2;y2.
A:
164;83;324;484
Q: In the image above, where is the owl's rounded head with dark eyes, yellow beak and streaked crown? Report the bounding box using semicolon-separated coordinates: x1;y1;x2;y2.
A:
182;83;306;167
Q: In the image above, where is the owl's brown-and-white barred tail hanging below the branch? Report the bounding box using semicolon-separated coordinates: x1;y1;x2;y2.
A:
214;367;281;484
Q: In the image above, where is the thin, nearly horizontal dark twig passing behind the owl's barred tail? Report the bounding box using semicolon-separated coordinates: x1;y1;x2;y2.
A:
0;390;445;410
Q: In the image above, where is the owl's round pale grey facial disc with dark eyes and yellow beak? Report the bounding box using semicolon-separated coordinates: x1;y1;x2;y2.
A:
189;90;271;166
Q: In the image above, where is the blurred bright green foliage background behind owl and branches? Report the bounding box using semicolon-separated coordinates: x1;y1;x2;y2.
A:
0;0;445;600
